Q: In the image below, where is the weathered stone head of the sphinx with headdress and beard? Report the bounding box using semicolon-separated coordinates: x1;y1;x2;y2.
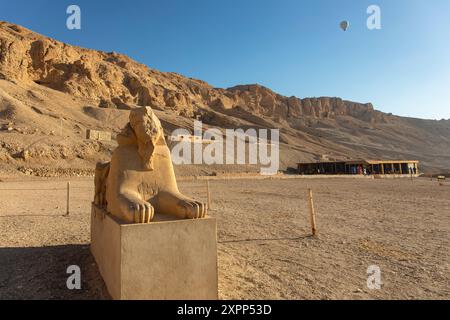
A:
118;107;164;170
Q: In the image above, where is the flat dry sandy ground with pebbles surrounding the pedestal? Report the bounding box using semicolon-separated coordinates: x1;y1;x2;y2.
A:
0;178;450;299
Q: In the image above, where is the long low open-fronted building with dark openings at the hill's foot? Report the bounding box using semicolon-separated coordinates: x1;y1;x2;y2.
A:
297;160;419;176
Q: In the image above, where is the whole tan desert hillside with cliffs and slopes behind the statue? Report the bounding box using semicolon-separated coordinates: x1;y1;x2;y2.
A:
0;22;450;178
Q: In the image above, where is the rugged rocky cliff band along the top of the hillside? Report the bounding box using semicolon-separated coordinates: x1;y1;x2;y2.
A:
0;22;386;122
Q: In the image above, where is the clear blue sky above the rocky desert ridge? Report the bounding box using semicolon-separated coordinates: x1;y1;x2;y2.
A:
0;0;450;119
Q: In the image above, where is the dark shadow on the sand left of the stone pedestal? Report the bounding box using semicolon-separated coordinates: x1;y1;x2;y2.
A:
0;245;110;300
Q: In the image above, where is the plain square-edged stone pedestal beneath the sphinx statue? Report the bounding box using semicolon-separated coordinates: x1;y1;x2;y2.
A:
91;205;218;300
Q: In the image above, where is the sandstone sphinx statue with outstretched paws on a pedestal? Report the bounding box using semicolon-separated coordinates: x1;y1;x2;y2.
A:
94;107;207;223
